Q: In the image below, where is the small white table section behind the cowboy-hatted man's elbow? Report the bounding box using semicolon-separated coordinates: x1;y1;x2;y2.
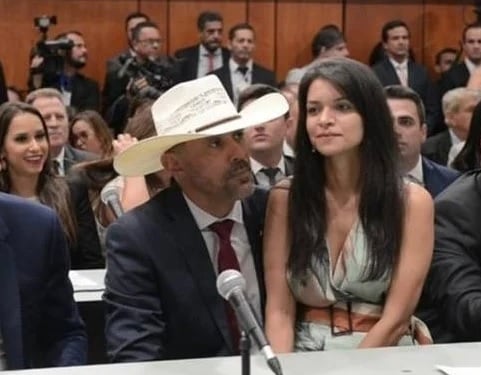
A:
69;269;105;302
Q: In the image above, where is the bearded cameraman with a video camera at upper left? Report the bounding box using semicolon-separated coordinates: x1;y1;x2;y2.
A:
29;31;100;111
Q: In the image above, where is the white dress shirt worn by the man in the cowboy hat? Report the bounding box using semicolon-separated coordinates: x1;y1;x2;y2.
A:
184;194;262;322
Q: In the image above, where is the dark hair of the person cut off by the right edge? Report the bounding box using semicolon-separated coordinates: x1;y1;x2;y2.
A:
451;102;481;172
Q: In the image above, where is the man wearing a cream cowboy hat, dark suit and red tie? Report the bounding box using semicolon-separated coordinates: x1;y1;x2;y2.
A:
104;75;288;362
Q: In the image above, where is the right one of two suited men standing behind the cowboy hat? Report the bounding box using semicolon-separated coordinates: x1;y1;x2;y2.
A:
212;23;277;104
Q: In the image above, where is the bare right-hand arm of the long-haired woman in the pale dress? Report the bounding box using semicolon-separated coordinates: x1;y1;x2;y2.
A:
359;184;434;348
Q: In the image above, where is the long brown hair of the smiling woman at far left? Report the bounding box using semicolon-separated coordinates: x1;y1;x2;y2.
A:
0;102;77;244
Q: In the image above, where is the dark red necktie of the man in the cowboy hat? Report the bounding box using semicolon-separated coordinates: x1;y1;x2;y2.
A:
210;219;240;353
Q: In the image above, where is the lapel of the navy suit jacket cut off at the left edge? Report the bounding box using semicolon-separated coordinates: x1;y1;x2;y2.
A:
0;218;25;370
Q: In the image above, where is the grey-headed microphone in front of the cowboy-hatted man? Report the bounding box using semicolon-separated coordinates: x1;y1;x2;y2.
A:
217;270;282;375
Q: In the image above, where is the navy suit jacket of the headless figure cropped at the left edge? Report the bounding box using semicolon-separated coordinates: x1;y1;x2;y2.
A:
0;193;87;369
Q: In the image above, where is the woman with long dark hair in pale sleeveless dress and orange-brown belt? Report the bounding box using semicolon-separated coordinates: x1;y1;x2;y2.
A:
264;59;434;352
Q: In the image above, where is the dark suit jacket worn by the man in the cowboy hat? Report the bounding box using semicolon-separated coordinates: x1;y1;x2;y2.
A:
104;187;267;362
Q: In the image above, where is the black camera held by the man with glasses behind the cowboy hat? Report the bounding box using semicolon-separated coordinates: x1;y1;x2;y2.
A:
117;54;176;100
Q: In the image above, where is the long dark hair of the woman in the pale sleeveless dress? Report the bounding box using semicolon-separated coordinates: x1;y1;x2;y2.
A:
288;59;404;280
